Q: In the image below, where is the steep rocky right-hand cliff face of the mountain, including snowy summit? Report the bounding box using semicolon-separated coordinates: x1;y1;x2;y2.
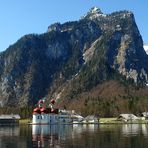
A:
84;8;148;83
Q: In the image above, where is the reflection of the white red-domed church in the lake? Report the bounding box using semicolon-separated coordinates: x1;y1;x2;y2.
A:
32;125;71;147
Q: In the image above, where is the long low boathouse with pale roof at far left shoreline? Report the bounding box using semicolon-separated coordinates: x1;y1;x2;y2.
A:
0;114;20;124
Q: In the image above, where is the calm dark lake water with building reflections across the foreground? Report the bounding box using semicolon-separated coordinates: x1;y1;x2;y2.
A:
0;124;148;148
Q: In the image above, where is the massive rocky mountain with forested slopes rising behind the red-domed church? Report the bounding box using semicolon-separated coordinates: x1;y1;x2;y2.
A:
0;7;148;113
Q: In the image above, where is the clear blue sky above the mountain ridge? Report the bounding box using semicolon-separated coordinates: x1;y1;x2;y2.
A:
0;0;148;51
